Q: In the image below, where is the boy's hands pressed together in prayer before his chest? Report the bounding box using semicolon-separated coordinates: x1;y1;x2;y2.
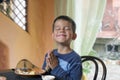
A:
46;51;58;69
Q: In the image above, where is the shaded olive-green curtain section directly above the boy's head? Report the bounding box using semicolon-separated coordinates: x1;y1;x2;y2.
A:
55;0;75;18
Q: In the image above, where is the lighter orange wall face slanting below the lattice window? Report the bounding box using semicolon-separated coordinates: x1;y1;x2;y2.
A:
0;13;34;67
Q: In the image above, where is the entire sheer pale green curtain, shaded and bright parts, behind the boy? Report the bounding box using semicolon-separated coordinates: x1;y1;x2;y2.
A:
55;0;106;55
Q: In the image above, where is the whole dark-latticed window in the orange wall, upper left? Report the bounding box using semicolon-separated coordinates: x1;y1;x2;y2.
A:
0;0;27;30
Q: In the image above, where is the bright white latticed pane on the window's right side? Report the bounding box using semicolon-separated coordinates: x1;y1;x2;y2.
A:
11;0;27;30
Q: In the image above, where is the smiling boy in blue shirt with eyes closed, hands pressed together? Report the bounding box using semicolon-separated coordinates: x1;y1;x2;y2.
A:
43;16;82;80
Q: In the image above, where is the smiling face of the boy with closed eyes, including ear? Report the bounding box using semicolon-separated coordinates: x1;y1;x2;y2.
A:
52;19;76;44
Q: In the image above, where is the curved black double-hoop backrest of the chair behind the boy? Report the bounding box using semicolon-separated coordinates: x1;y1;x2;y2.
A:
81;56;107;80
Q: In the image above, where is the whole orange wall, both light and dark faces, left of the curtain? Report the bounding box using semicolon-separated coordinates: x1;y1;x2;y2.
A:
0;0;54;68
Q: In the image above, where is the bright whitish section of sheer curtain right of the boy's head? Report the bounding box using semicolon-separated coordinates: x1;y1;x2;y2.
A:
74;0;106;55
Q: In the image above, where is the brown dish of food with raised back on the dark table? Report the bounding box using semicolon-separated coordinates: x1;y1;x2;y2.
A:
15;59;44;76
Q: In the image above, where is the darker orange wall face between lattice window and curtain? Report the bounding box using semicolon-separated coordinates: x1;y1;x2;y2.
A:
28;0;54;64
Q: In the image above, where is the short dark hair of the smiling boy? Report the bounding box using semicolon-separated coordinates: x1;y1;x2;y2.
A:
52;15;76;33
